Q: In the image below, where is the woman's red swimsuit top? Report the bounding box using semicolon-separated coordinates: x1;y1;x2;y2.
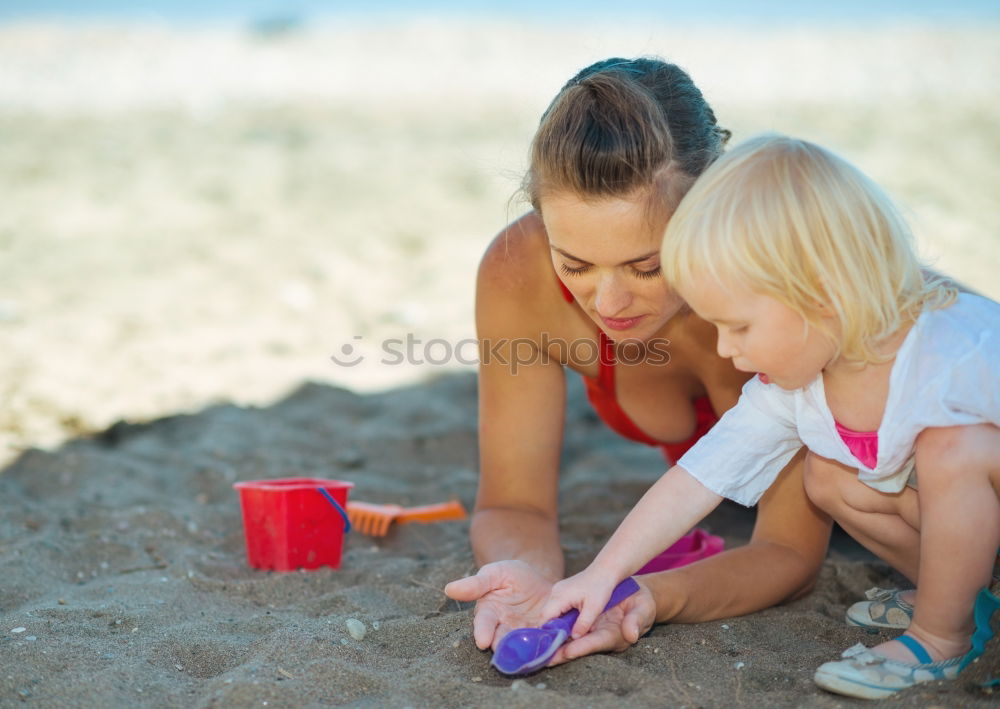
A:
559;281;719;463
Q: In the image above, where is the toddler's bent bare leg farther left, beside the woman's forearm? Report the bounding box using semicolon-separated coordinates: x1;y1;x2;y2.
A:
804;453;920;585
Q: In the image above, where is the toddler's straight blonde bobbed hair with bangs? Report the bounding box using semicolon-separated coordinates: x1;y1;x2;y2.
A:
661;135;956;362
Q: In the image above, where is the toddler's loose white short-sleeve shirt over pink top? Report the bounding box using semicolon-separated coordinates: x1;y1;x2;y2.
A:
678;293;1000;506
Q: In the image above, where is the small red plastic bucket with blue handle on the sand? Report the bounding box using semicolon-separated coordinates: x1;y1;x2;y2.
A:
233;478;354;571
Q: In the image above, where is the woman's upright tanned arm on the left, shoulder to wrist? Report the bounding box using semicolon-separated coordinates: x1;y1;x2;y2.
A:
471;215;566;581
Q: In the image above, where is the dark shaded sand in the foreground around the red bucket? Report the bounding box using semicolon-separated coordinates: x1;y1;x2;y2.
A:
0;374;995;707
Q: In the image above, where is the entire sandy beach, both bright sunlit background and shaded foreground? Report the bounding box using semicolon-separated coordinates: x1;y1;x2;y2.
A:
0;21;1000;708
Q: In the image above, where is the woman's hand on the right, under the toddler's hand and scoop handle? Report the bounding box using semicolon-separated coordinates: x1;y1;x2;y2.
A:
549;576;656;666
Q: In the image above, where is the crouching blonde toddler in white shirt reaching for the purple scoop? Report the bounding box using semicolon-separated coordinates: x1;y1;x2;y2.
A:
545;135;1000;698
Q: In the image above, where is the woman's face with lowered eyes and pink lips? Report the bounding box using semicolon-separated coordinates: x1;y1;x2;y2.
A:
542;192;683;341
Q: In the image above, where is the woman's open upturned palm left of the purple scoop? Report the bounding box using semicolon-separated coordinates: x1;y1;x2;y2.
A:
444;561;552;650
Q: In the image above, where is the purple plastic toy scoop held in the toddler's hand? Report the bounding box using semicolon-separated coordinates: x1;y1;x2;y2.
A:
491;576;639;675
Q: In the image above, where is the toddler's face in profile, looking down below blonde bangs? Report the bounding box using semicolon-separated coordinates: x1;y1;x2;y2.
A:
681;276;836;389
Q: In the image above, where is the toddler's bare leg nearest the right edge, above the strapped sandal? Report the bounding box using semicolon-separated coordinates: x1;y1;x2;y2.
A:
904;424;1000;660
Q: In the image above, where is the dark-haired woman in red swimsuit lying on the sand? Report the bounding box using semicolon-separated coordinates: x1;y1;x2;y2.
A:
446;58;830;663
